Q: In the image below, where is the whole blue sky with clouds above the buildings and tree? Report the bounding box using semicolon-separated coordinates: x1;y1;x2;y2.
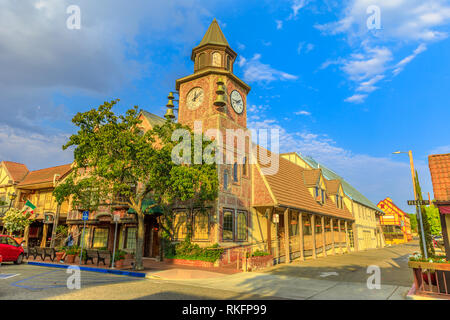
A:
0;0;450;211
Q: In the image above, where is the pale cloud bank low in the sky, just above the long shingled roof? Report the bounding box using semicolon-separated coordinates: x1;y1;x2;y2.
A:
249;119;432;212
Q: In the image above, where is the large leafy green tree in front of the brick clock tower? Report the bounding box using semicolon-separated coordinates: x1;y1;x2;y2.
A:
54;100;218;270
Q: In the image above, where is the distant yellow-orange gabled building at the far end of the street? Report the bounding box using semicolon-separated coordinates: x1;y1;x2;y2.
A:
377;198;412;244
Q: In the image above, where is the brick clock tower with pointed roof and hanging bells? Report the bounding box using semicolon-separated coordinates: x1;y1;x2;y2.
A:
176;19;252;246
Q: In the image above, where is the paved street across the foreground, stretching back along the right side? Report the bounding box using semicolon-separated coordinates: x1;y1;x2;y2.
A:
0;241;418;300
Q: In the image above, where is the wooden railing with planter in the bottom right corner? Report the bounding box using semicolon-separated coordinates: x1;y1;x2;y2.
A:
408;261;450;299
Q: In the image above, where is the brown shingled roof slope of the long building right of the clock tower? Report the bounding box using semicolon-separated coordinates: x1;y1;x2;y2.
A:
257;147;354;220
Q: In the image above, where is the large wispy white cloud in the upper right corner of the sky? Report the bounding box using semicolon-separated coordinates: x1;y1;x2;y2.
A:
316;0;450;103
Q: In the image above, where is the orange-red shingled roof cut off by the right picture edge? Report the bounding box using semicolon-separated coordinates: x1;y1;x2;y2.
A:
428;153;450;201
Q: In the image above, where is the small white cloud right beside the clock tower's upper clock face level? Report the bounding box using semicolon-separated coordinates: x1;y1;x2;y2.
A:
239;53;298;82
